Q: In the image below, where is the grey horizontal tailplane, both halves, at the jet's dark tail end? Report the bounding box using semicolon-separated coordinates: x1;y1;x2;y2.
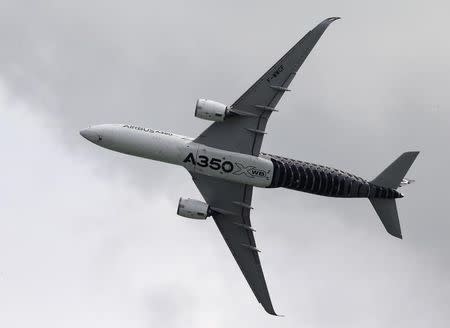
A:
369;151;419;239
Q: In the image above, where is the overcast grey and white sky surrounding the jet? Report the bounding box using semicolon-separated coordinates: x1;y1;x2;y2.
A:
0;0;450;328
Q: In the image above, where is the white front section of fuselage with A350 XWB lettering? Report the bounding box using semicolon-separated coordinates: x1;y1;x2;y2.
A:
80;124;273;187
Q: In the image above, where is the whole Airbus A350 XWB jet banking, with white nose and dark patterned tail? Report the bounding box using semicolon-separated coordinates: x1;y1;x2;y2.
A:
80;17;418;315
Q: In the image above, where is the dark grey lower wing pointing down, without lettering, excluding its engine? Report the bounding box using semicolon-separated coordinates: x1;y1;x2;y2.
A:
188;173;277;315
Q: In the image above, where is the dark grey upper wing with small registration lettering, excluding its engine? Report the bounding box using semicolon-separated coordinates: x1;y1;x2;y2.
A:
195;17;339;156
